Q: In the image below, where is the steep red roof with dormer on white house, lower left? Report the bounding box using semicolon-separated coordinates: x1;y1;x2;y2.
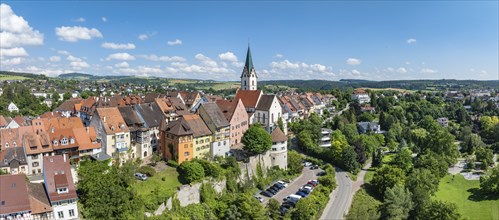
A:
43;155;77;203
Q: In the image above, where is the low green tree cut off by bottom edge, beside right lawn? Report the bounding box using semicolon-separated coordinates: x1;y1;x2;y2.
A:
421;200;461;220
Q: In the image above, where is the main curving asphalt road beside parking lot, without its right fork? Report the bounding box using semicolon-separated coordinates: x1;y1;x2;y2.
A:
320;168;352;220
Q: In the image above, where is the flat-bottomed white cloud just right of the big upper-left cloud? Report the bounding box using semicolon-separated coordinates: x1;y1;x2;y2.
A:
55;26;102;42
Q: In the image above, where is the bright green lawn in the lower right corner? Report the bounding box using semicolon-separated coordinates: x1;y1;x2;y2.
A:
436;175;499;219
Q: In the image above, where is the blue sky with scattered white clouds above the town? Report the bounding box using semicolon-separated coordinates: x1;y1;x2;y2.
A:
0;1;499;81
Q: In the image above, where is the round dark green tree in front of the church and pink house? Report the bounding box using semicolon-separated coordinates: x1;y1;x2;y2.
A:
241;124;272;154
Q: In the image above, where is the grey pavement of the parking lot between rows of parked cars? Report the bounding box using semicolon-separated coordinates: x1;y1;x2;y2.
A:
258;167;322;204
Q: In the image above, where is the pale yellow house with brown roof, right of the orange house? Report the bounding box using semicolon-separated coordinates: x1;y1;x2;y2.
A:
183;115;213;159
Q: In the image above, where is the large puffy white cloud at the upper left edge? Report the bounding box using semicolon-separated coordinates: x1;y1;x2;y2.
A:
0;3;43;48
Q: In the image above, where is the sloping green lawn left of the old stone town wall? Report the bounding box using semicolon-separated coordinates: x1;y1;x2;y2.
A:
134;167;182;211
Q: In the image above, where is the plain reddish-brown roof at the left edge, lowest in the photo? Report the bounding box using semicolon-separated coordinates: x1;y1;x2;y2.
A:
0;174;31;214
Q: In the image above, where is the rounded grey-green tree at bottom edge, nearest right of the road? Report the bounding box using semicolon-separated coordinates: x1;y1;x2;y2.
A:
381;185;413;220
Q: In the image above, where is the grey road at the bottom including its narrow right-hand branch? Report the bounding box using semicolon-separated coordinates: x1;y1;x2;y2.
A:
320;161;371;220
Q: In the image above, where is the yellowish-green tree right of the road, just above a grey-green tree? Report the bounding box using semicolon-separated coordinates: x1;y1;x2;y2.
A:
371;165;405;197
